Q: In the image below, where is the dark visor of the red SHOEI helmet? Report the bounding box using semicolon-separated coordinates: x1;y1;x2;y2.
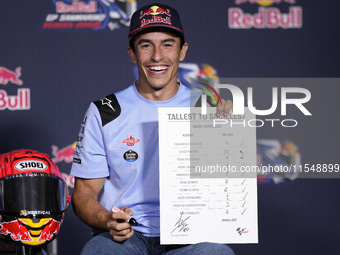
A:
0;173;67;217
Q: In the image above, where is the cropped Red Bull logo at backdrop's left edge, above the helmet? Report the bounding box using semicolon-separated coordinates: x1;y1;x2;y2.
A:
0;66;31;111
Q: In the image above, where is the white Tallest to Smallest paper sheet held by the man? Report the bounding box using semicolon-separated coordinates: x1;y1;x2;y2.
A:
159;108;258;244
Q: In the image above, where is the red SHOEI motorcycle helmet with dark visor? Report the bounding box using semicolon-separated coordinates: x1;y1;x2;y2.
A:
0;149;70;246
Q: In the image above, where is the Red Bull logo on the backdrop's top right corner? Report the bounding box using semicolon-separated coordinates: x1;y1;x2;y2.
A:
228;0;302;29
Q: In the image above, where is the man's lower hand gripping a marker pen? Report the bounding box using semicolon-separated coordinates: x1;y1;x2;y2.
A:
107;206;134;242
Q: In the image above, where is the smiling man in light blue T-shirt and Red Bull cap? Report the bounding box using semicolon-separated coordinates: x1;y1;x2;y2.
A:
71;3;234;255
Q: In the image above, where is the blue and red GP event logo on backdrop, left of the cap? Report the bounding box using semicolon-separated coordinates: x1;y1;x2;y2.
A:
42;0;137;31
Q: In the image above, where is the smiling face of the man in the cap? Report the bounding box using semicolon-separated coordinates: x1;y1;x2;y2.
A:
128;32;188;96
